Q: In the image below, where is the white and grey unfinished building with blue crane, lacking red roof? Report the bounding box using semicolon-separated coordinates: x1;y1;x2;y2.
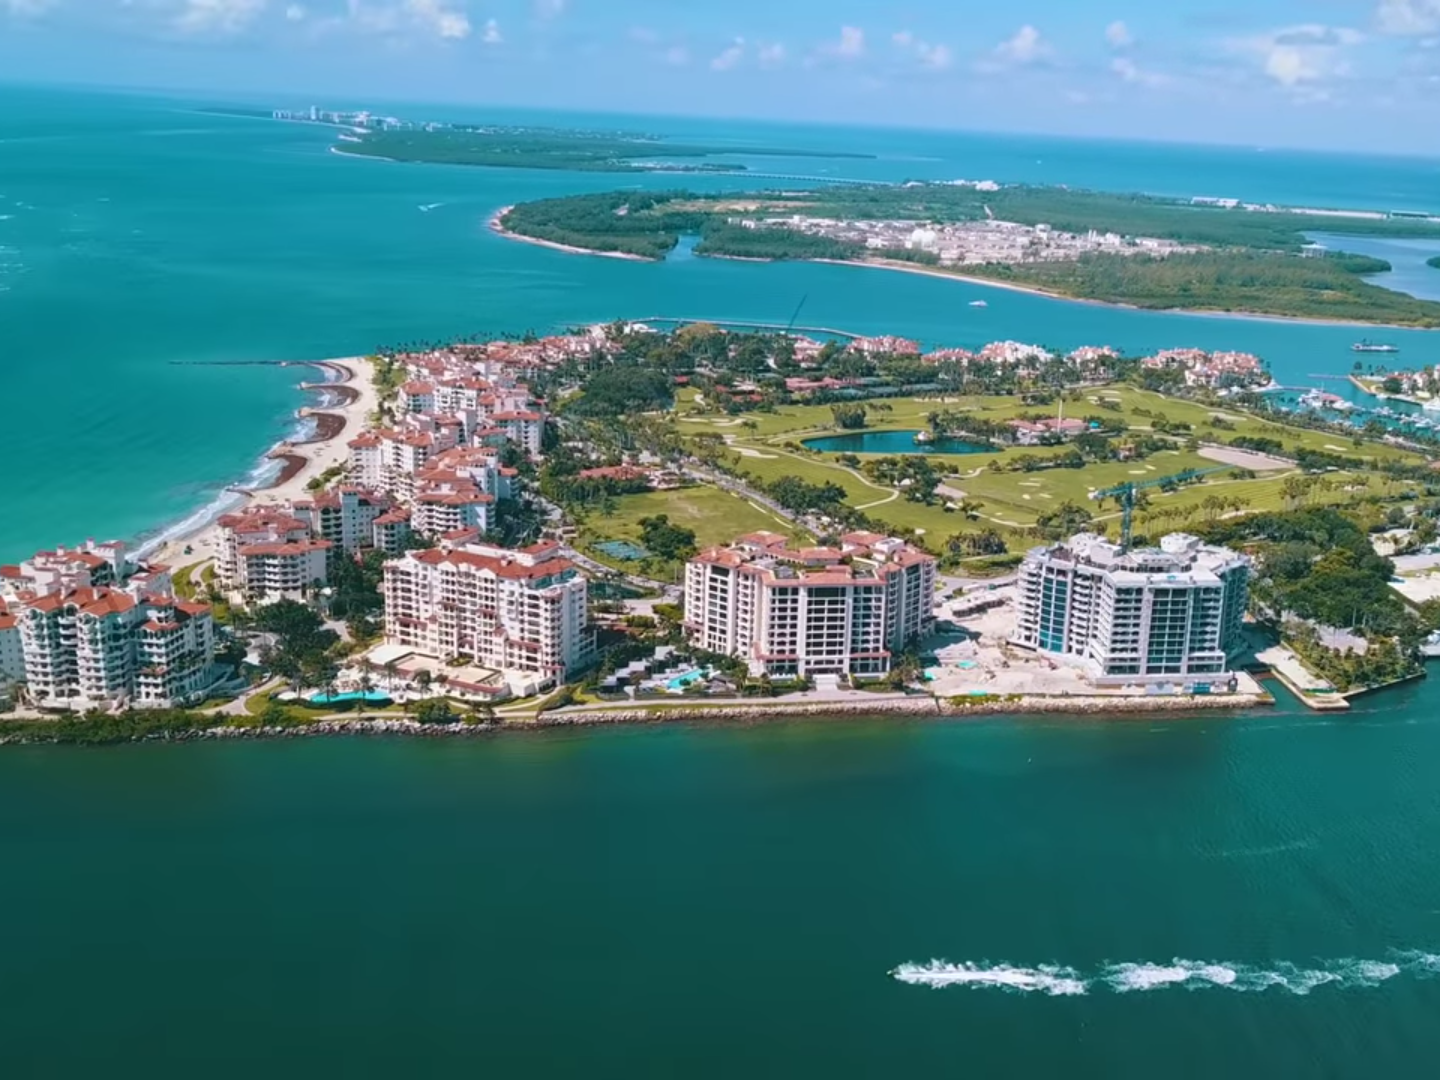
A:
1012;533;1250;684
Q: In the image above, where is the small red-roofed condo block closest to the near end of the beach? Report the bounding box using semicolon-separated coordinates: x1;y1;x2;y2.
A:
215;505;333;602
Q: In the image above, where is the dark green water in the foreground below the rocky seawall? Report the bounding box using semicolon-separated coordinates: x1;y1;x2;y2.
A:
0;685;1440;1077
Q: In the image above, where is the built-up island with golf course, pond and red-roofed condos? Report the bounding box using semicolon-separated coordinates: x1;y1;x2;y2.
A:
0;321;1440;743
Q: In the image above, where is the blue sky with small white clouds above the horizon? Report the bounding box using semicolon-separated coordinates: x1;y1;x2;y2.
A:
0;0;1440;156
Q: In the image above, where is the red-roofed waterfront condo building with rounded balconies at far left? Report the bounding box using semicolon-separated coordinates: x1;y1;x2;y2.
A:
17;586;215;708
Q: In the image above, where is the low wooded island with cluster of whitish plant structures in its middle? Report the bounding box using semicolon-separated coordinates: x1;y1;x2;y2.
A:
494;181;1440;327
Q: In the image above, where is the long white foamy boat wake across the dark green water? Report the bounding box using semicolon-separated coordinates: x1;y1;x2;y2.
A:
890;952;1440;998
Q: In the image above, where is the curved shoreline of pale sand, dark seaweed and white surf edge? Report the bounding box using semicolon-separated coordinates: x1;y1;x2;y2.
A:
135;356;377;567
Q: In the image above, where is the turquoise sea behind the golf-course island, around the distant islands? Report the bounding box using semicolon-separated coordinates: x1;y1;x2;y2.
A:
0;88;1440;559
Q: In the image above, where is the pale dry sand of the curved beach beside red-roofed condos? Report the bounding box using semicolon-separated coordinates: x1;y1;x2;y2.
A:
151;357;379;567
